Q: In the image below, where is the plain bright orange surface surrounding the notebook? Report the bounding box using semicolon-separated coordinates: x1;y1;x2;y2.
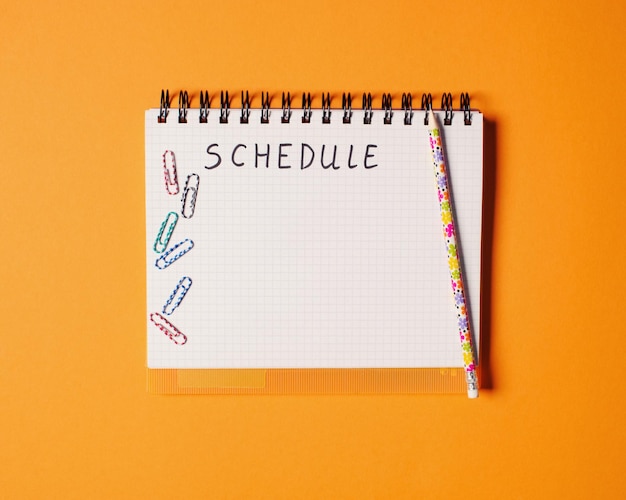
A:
0;0;626;499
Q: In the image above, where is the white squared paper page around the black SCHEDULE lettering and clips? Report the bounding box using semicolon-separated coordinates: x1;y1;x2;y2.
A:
146;109;482;368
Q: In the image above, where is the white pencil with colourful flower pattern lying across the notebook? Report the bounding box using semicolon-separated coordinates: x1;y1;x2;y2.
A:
428;110;478;398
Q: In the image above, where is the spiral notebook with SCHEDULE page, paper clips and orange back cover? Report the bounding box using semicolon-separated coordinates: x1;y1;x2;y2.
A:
145;92;483;394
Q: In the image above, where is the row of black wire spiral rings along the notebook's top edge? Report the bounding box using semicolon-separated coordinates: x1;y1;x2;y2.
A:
158;89;472;126
